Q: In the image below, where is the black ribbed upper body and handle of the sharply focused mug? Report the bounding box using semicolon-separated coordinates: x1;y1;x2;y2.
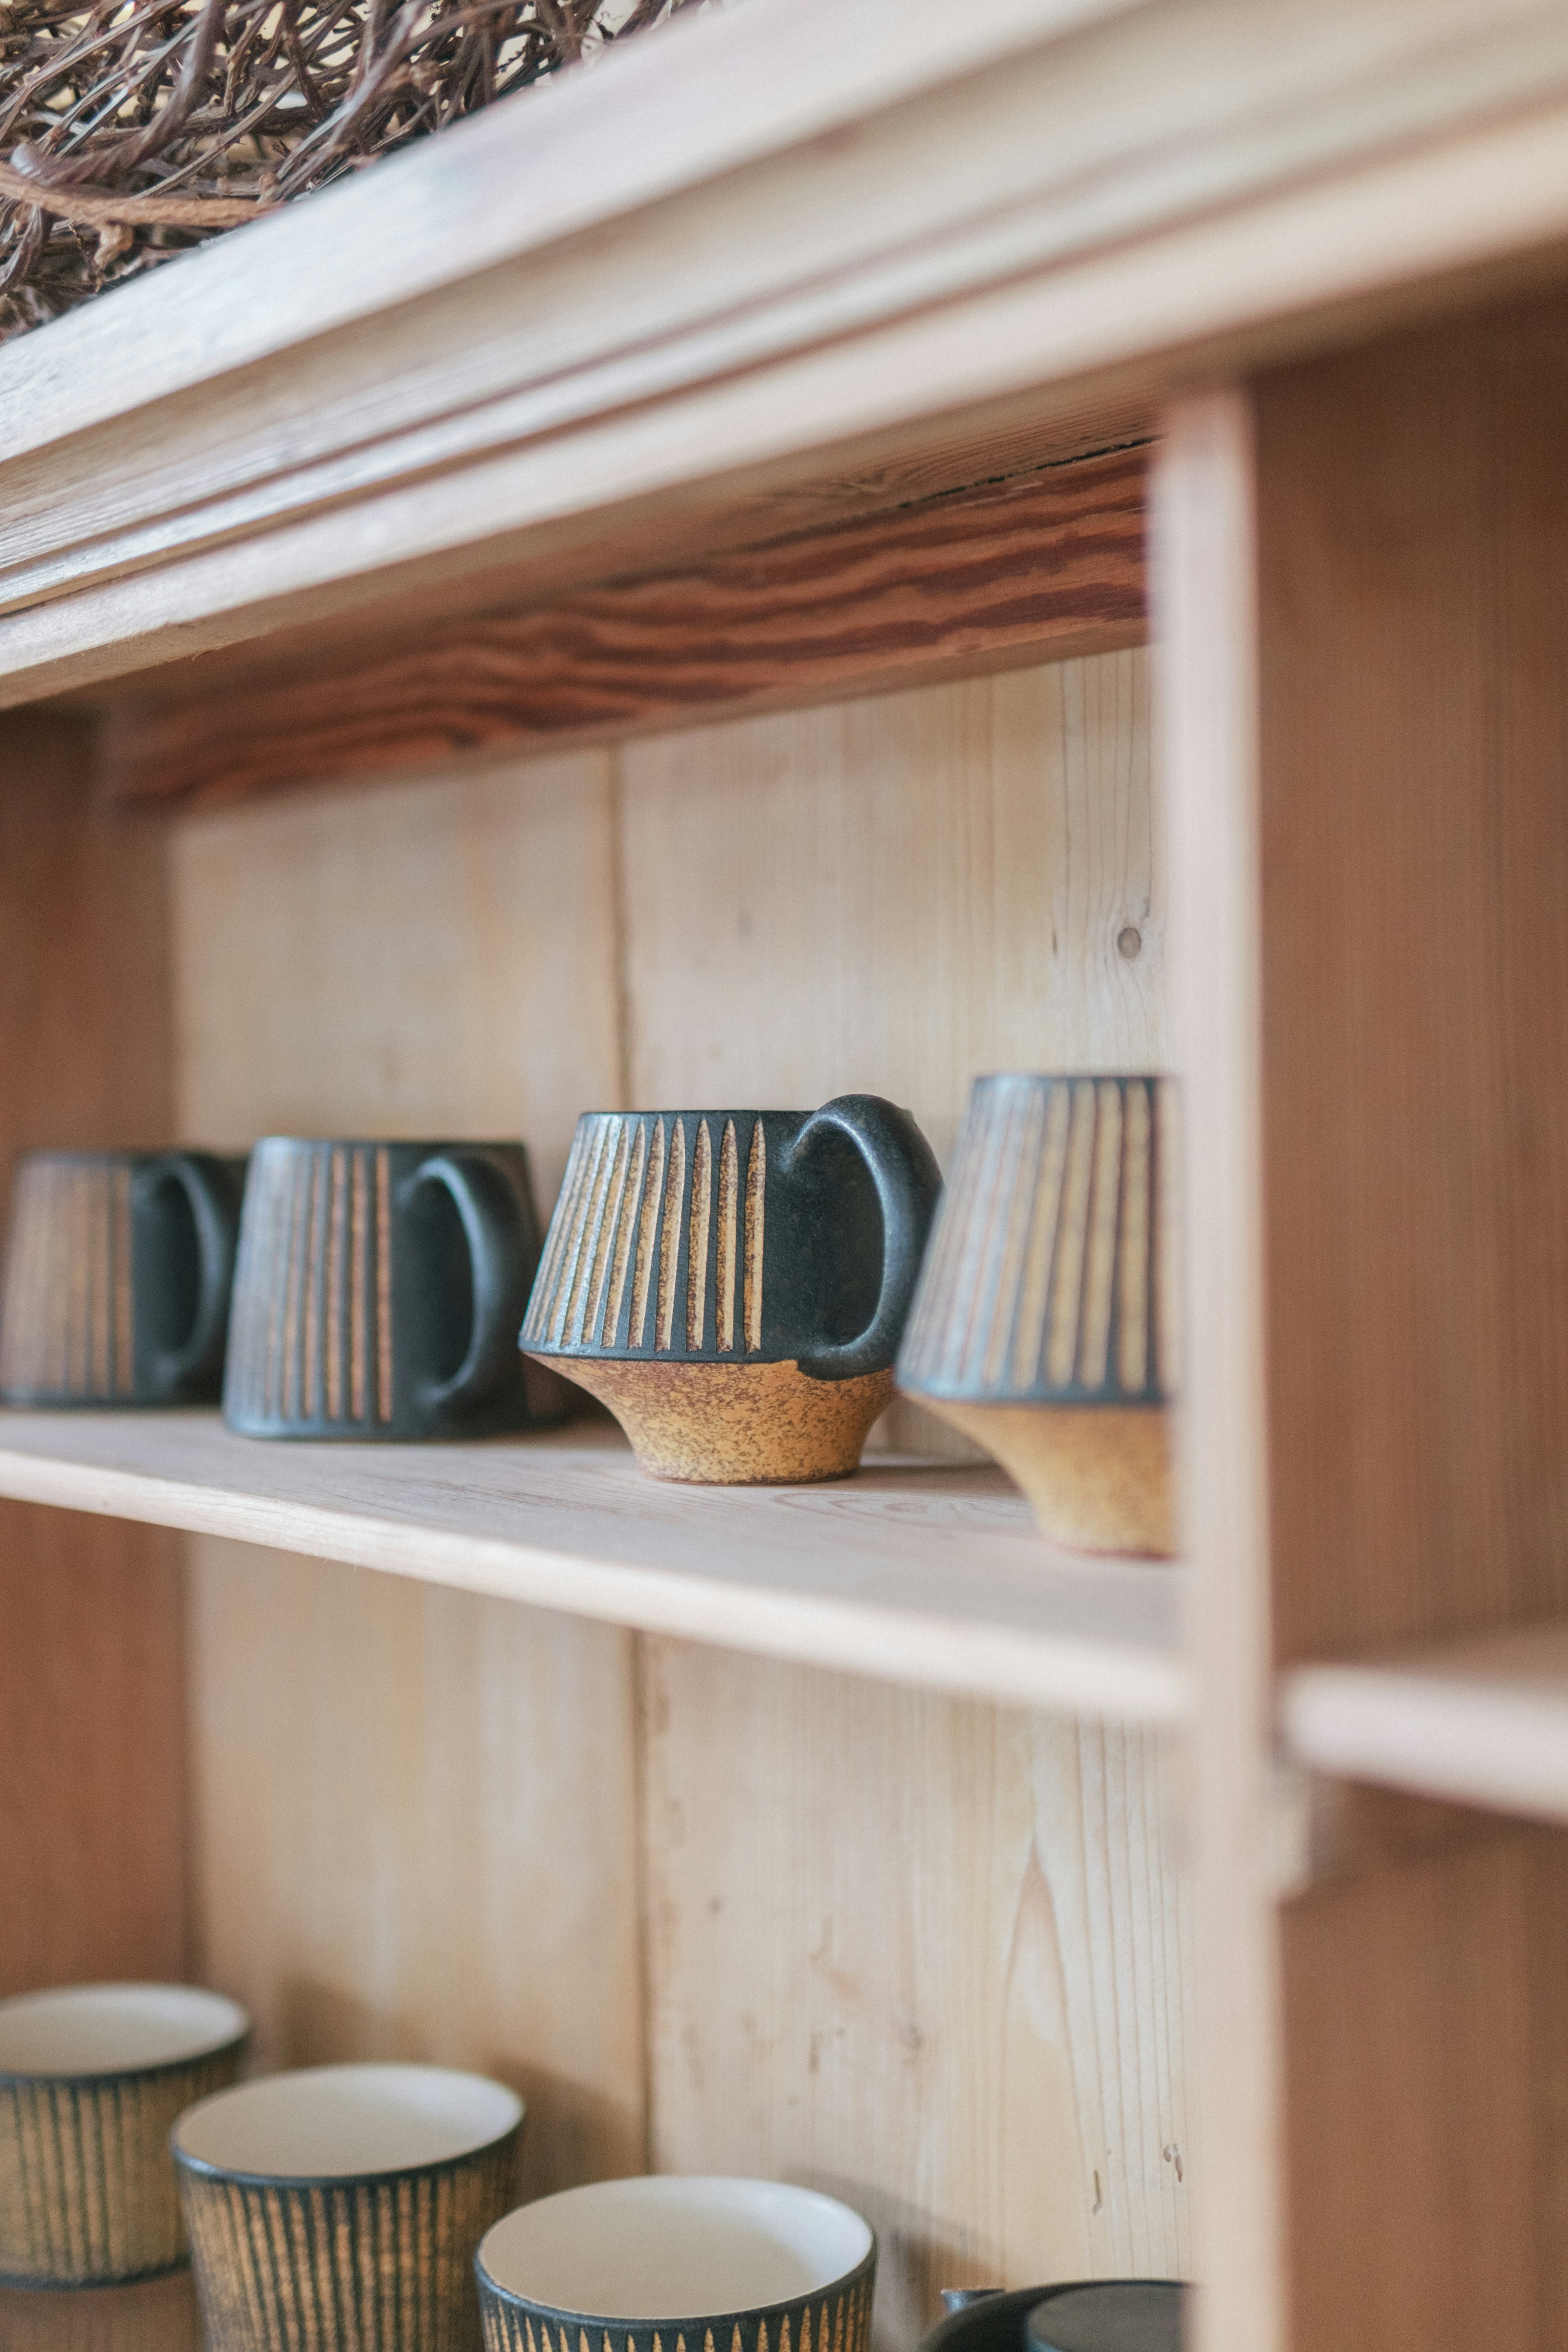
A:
522;1094;943;1381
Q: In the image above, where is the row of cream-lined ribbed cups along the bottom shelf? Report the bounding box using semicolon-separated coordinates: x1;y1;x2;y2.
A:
0;1985;1178;2352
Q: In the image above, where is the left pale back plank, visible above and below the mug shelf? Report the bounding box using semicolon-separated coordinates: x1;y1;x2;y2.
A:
174;755;644;2187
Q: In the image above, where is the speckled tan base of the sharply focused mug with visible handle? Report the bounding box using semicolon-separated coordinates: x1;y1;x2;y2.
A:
541;1357;893;1486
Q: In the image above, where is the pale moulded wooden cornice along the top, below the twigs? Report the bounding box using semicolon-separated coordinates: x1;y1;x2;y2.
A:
0;0;1568;696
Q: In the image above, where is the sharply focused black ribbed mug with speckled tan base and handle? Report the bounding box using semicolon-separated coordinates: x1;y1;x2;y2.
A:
522;1094;940;1484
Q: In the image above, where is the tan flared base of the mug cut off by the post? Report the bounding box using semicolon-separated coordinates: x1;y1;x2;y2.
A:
919;1397;1176;1559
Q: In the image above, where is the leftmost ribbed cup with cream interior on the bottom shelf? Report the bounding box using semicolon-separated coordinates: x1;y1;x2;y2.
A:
0;1985;249;2286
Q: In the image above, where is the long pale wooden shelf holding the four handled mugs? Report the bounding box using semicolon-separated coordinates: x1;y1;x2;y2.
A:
0;1414;1185;1722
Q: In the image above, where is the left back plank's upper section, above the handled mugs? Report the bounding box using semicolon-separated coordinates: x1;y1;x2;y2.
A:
172;753;621;1216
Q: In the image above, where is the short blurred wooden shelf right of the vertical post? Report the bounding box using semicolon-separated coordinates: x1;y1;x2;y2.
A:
1281;1623;1568;1820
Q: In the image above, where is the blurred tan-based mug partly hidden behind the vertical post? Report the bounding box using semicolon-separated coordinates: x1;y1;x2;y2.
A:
898;1075;1180;1552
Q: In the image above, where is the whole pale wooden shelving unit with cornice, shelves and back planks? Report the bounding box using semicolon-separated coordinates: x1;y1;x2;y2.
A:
0;0;1568;2352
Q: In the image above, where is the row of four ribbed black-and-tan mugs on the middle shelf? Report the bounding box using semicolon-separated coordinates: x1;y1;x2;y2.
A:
0;1073;1180;1552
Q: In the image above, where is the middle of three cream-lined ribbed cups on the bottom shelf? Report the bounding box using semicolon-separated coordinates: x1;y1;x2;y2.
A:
174;2065;522;2352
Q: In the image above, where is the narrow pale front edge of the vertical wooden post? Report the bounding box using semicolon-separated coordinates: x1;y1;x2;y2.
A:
1152;390;1288;2352
